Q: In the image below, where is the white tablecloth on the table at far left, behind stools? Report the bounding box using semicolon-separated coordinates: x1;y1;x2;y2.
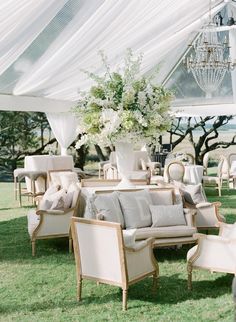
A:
24;155;74;192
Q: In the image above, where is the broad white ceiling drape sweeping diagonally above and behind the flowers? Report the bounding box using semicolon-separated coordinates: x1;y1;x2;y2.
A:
14;0;225;100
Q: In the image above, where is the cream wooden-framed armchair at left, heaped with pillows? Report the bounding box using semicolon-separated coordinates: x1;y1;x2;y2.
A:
28;187;80;256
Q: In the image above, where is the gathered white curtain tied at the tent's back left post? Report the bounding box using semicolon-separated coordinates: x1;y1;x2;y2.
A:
46;113;76;155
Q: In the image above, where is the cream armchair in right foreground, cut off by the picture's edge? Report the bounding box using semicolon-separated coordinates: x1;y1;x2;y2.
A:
187;223;236;289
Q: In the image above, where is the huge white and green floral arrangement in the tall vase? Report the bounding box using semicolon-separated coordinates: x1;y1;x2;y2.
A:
74;50;172;148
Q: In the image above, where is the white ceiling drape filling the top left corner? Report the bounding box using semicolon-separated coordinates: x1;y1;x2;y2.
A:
0;0;68;74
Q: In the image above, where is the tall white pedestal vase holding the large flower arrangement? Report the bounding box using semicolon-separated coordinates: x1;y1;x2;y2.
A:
115;142;134;188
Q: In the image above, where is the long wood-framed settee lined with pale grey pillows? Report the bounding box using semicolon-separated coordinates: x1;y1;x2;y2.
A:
87;188;197;247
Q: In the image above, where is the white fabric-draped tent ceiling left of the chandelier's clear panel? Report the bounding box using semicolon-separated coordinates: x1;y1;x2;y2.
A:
0;0;236;114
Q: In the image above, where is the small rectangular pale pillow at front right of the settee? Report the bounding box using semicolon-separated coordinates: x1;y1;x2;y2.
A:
150;204;186;227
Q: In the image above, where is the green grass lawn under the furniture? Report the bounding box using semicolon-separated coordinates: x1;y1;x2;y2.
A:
0;183;236;322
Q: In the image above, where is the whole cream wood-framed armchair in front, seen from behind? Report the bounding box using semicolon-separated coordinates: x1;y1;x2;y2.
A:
72;217;158;310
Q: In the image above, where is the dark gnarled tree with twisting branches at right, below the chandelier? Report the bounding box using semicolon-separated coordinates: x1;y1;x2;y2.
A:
168;115;236;164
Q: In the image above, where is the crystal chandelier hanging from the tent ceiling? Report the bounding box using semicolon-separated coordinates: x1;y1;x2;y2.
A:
186;3;234;98
